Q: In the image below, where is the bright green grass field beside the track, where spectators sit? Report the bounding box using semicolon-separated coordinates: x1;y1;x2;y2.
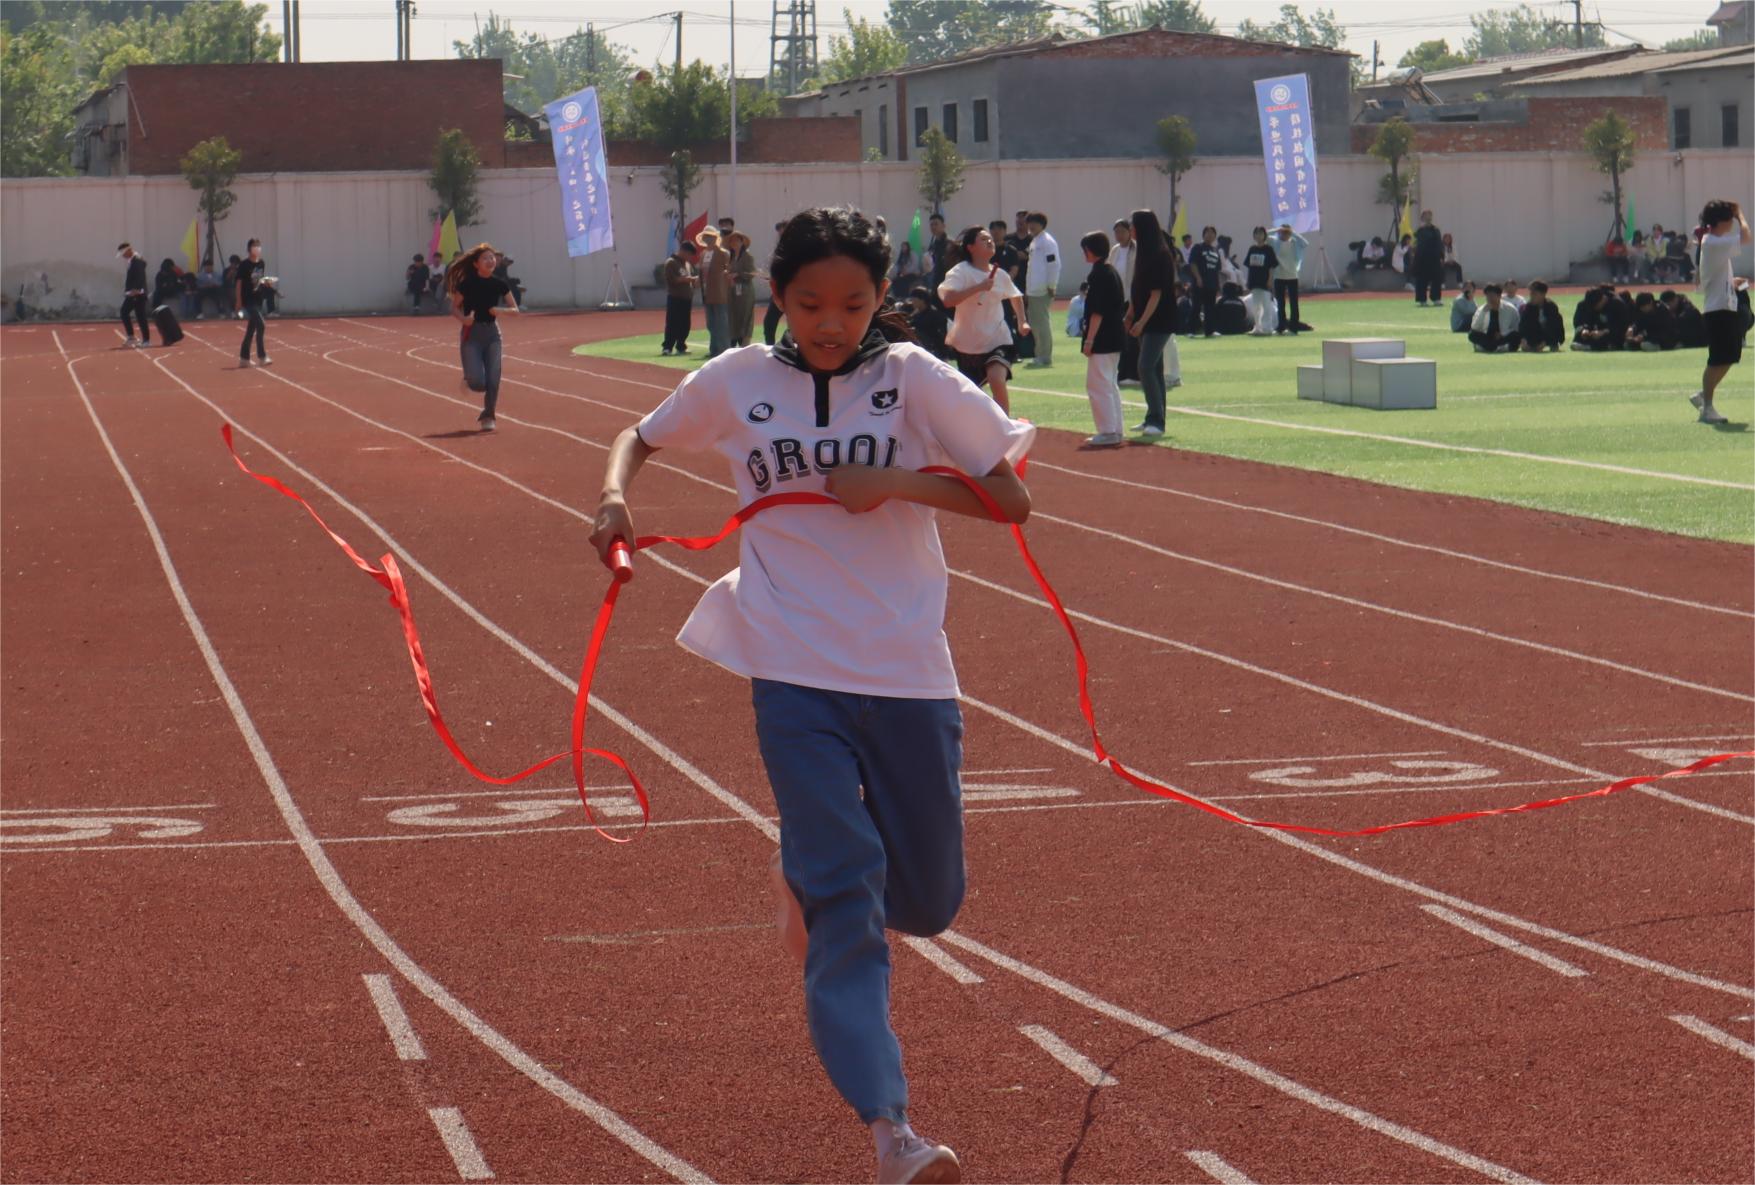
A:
576;295;1755;542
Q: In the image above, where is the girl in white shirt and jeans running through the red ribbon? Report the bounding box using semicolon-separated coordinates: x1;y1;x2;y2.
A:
591;209;1035;1181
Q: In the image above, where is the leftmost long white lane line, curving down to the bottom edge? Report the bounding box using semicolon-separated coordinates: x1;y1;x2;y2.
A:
83;347;709;1181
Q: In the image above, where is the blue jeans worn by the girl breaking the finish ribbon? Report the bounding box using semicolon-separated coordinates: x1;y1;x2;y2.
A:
751;679;963;1124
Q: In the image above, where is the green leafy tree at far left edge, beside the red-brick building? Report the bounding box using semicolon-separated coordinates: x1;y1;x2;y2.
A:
0;23;79;177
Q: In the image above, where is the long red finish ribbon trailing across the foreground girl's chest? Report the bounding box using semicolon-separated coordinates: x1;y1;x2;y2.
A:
219;423;1755;843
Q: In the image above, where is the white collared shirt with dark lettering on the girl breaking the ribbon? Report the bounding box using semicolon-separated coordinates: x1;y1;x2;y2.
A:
639;344;1035;699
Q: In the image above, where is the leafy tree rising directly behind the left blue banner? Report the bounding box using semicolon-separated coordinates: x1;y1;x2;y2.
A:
453;12;634;135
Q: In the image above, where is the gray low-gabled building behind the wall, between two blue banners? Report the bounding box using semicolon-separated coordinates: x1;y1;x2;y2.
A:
781;28;1353;162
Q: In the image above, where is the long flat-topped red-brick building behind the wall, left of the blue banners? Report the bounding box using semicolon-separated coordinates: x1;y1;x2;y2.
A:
72;58;505;177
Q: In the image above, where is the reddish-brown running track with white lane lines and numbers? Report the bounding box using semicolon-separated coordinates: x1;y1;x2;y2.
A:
0;314;1755;1181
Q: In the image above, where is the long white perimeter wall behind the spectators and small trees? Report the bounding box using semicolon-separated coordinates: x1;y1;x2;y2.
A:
0;149;1755;314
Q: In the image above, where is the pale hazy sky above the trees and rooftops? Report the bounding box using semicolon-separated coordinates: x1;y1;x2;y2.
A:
267;0;1718;75
